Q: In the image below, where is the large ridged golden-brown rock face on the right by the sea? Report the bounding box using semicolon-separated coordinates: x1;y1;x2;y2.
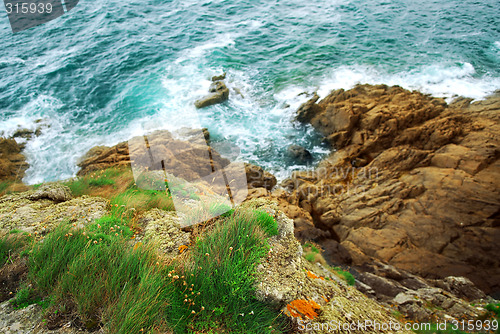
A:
287;85;500;293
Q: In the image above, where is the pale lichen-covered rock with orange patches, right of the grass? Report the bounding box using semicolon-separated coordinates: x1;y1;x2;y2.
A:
245;199;412;333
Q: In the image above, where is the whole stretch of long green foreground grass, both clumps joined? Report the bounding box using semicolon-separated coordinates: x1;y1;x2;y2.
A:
16;207;285;334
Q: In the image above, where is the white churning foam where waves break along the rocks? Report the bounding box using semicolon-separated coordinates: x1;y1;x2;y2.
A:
9;47;500;184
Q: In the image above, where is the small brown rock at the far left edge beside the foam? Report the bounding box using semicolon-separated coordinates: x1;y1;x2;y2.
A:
0;138;29;180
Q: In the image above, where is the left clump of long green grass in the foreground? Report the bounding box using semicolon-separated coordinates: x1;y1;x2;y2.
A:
21;225;180;333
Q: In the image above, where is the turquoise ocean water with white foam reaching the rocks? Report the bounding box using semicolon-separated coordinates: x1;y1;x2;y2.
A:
0;0;500;183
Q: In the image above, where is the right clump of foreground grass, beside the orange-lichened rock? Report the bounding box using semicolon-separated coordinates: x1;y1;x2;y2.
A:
186;211;284;333
